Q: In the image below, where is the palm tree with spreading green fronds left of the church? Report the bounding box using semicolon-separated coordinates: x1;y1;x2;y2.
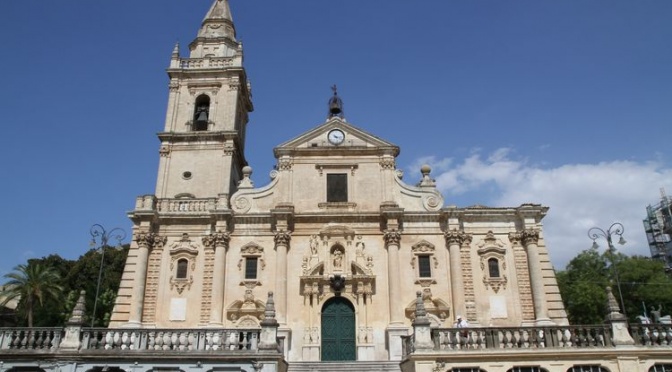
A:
0;263;63;327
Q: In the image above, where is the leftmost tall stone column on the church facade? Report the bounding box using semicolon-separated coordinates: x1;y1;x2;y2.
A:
128;232;159;327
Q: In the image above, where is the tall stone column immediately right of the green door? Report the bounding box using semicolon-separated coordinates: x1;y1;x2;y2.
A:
383;230;404;325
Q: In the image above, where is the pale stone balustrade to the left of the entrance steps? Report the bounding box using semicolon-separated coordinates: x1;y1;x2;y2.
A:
0;328;261;353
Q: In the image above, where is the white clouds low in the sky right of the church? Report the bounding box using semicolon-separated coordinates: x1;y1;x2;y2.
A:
415;148;672;269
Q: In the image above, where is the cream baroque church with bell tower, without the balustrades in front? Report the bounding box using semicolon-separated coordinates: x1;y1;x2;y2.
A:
110;0;568;362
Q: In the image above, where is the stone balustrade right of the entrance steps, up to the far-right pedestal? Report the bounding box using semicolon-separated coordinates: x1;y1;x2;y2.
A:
402;325;614;355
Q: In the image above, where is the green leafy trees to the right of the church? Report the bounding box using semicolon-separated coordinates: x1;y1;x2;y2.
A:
557;249;672;324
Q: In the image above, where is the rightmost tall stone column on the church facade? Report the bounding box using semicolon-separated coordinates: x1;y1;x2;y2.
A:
521;229;551;324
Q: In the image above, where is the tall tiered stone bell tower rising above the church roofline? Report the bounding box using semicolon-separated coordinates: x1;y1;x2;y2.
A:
155;0;253;199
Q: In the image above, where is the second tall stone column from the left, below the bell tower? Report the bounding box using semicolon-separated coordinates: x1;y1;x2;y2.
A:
203;231;231;326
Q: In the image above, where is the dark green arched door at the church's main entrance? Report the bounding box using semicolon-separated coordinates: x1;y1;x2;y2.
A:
322;297;357;361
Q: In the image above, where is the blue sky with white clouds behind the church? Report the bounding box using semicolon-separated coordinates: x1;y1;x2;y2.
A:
0;0;672;274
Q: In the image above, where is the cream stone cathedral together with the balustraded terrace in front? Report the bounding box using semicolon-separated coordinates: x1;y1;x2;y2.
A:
5;0;672;372
